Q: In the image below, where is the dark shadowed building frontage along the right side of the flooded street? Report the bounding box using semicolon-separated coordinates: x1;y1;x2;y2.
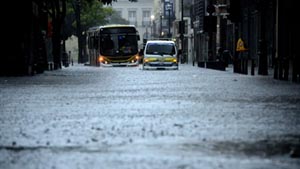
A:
192;0;300;82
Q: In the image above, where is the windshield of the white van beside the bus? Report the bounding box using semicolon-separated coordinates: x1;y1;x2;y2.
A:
146;43;175;55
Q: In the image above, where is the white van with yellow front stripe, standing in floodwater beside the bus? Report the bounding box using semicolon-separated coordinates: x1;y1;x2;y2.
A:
142;40;178;70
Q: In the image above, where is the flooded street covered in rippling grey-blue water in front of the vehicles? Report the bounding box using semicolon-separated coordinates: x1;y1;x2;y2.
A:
0;64;300;169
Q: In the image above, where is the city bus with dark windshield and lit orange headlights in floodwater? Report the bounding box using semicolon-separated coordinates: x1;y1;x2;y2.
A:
87;25;140;66
